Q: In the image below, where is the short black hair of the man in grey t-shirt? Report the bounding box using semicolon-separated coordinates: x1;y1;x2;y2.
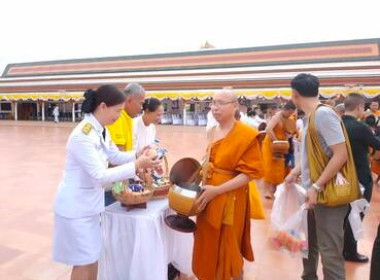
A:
290;73;319;97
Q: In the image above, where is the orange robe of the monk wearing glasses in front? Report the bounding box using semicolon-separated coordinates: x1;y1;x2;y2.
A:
193;122;263;280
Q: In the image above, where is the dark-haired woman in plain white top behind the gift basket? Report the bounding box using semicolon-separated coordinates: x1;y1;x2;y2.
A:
133;98;164;152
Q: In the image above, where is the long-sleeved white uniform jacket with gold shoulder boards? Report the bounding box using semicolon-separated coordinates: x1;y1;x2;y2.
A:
54;114;136;218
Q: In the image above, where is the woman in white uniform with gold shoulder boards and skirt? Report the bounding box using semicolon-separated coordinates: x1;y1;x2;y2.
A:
53;85;158;280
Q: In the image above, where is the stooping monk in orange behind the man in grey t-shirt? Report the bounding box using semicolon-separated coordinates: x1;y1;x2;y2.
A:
262;102;296;199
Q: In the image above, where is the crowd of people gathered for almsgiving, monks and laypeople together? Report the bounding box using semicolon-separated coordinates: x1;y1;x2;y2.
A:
53;74;380;280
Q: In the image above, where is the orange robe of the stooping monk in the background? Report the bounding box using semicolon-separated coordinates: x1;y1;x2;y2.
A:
262;121;287;185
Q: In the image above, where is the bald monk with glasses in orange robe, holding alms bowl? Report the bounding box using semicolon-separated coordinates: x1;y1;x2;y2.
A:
193;90;264;280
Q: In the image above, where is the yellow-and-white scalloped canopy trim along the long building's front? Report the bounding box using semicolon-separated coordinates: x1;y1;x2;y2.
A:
0;86;380;102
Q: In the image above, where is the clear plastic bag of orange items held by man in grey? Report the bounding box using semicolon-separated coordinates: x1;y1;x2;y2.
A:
270;185;308;258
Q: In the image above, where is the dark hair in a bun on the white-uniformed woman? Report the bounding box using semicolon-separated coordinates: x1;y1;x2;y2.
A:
82;85;125;113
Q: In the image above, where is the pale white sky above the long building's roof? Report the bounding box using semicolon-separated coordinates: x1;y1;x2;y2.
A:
0;0;380;73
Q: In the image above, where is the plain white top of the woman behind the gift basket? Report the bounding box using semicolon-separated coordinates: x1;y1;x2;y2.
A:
133;116;156;152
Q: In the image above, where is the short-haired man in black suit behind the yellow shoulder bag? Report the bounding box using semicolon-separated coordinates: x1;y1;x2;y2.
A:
342;93;380;262
